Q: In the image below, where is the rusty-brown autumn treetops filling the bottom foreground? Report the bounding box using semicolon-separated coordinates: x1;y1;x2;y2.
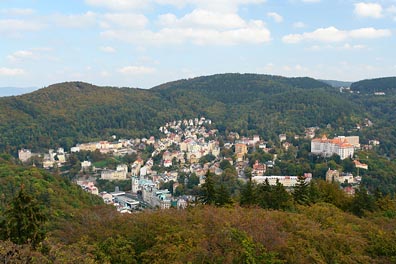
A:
0;203;396;263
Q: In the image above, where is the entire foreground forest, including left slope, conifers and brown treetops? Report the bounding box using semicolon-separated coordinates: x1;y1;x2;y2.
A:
0;155;396;264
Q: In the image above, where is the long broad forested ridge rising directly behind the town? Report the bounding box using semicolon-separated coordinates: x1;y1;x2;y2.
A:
0;74;396;157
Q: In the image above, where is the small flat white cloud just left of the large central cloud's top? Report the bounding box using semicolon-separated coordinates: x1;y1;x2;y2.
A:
102;13;148;28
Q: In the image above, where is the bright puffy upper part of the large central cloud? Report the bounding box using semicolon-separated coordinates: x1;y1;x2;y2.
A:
158;9;246;28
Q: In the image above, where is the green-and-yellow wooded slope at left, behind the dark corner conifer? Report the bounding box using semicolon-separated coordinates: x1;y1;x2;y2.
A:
0;154;103;230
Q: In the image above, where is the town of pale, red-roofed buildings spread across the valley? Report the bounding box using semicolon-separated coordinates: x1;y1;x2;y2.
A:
18;117;379;213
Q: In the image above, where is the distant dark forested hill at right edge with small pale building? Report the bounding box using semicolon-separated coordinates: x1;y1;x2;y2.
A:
351;77;396;95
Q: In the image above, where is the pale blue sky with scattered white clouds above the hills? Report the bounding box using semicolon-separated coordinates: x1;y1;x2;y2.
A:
0;0;396;95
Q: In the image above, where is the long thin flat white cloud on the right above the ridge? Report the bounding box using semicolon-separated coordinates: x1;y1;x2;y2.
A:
282;27;392;43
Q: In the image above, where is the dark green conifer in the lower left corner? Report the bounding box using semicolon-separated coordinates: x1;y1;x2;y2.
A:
1;185;46;247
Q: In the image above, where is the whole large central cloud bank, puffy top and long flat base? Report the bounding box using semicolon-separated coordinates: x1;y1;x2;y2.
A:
101;9;271;45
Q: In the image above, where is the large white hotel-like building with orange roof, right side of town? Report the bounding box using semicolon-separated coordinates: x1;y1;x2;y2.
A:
311;136;360;159
